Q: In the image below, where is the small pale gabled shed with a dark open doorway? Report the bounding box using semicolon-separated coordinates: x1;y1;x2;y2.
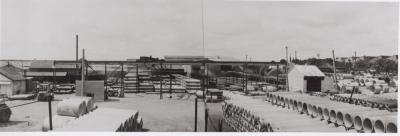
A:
288;65;325;92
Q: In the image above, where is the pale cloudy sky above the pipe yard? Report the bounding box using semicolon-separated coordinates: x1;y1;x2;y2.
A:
0;0;398;61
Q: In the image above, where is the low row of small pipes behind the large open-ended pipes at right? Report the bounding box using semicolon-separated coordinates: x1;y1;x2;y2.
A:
331;93;397;111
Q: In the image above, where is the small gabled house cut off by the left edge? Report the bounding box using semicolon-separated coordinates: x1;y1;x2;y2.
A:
0;65;26;96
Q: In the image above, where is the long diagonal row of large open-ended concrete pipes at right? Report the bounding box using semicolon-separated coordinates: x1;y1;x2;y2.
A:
266;92;397;133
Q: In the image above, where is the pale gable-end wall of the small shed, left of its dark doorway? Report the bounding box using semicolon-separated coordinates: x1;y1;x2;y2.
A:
288;69;305;92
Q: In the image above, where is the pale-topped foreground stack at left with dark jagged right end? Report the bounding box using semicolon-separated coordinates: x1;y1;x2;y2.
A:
56;108;143;132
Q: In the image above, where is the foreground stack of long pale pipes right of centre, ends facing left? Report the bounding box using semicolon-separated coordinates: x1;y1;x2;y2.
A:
222;92;345;132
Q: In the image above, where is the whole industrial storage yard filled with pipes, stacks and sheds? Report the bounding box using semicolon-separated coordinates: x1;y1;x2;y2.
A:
0;55;398;133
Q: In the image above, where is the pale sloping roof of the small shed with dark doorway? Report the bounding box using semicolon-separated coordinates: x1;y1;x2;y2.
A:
290;65;325;77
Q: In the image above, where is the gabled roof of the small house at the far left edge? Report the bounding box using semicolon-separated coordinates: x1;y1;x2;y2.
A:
0;65;25;81
